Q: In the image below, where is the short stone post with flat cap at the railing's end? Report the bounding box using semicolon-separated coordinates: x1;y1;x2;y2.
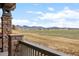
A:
8;34;23;56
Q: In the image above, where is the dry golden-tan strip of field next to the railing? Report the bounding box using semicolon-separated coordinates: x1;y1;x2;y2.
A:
23;33;79;55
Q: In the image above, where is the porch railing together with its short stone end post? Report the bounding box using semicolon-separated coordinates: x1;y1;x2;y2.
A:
8;34;69;56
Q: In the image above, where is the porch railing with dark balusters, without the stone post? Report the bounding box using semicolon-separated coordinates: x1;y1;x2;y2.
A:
15;41;67;56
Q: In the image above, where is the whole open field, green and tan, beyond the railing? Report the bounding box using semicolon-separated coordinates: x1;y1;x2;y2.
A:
18;30;79;55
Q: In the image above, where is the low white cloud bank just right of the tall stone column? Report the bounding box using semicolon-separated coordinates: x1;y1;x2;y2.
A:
12;19;40;26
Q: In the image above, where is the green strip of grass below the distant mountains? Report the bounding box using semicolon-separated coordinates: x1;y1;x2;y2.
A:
21;29;79;39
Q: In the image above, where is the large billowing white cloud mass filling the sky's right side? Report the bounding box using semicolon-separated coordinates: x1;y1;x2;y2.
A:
39;7;79;27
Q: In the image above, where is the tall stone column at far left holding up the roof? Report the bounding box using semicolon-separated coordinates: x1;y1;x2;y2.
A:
1;14;12;51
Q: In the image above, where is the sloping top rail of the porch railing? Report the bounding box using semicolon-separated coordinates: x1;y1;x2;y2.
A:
19;40;70;56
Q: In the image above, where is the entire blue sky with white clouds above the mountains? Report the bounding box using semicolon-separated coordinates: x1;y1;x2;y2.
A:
0;3;79;28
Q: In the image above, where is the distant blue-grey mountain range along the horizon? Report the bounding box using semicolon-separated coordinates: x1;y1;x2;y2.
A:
15;25;79;30
